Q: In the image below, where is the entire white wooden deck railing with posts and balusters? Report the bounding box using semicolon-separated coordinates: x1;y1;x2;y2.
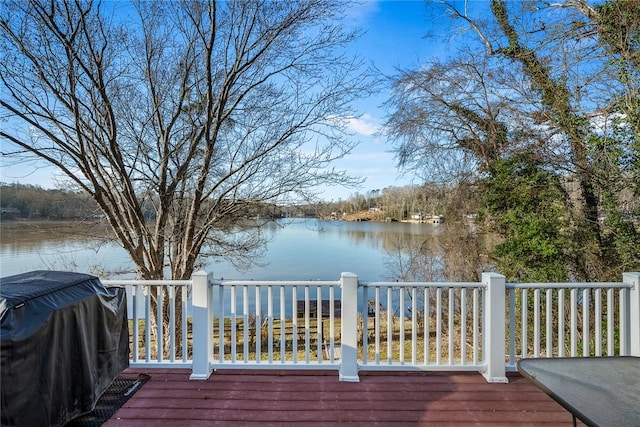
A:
103;272;640;382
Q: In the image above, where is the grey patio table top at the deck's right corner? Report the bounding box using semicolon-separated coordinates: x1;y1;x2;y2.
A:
517;356;640;427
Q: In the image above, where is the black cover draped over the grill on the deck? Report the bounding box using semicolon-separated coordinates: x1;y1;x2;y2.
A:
0;271;129;426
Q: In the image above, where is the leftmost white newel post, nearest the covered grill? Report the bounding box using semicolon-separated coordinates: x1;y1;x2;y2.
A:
189;271;213;380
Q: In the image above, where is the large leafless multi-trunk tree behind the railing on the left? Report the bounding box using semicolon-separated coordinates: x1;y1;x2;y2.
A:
0;0;369;279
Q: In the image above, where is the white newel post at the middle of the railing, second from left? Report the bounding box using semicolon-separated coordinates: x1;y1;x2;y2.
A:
340;273;360;382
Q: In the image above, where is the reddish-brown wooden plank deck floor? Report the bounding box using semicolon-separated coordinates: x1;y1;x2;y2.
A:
104;369;573;427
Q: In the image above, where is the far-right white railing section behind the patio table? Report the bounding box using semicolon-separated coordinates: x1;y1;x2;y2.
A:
507;273;640;367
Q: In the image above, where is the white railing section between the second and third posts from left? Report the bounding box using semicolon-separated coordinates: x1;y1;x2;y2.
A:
361;282;485;370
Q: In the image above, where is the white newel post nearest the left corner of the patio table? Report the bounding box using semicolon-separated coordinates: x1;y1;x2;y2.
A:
482;273;508;383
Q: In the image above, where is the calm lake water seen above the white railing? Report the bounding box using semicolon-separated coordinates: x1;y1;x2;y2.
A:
0;219;441;281
